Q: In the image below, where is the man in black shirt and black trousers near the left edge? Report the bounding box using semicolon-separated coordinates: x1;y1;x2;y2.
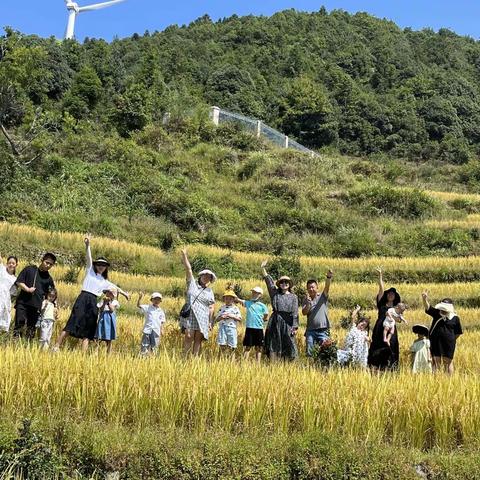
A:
13;253;57;340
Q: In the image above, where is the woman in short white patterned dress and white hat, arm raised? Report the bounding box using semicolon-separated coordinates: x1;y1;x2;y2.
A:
180;249;217;356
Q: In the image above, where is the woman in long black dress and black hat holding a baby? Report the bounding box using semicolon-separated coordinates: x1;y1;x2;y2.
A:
368;268;401;370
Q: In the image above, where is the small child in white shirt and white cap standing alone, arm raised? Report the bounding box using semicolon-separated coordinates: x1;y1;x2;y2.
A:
137;292;166;355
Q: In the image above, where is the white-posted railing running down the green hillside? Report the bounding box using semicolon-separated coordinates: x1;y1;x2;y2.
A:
210;107;318;157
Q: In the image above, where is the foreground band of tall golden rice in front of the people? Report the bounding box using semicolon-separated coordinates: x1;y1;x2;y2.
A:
0;339;480;449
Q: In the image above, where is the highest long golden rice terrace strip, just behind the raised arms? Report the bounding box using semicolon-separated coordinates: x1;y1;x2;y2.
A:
6;219;480;281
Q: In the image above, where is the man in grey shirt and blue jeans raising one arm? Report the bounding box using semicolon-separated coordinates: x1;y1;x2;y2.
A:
302;270;333;357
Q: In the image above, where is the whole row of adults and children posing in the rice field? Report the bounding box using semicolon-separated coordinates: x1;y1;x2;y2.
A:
0;236;462;373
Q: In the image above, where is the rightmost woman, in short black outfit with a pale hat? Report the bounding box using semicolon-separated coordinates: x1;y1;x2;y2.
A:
422;291;463;375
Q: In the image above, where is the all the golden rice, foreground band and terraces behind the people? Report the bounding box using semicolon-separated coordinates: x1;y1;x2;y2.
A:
0;224;480;449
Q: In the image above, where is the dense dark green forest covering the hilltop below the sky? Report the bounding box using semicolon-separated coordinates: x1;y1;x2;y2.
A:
0;9;480;159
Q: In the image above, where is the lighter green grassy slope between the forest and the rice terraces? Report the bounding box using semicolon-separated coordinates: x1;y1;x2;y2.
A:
0;126;480;262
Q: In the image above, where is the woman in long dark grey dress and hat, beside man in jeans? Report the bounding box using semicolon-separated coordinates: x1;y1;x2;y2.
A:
261;260;298;361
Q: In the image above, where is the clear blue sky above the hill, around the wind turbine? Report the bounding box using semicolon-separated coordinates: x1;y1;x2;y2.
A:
0;0;480;40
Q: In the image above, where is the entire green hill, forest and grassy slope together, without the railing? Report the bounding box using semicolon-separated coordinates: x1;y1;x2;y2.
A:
0;9;480;256
